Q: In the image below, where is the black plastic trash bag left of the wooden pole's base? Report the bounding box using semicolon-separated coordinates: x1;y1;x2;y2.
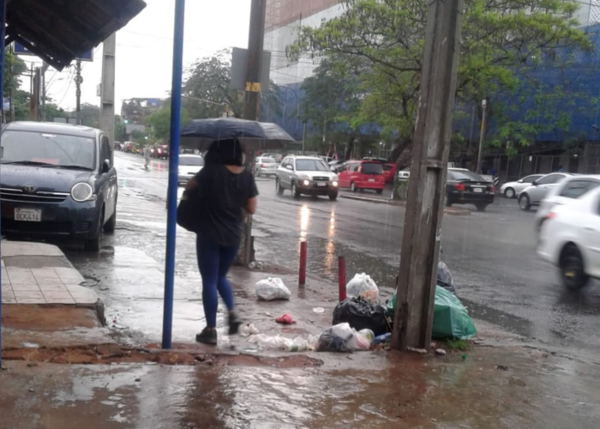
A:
332;298;390;336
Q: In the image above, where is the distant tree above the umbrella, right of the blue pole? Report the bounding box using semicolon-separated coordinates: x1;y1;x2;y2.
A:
182;50;281;119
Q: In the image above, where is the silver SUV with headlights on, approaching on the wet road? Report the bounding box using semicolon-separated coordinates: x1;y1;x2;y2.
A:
275;156;338;201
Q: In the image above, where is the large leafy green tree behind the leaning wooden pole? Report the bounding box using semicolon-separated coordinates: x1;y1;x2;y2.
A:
287;0;590;155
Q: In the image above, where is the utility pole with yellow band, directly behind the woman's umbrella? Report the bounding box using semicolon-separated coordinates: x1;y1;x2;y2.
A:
237;0;267;266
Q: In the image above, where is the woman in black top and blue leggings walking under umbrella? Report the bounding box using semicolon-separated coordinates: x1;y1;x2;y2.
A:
186;140;258;345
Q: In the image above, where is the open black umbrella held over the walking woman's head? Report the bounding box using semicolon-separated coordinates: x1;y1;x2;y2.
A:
181;118;295;151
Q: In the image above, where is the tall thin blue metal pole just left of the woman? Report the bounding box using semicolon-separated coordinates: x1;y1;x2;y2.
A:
162;0;185;349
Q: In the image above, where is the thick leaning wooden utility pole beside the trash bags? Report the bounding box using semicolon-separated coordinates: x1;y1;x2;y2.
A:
392;0;463;350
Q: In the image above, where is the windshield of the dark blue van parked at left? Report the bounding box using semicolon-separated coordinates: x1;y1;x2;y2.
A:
2;131;96;170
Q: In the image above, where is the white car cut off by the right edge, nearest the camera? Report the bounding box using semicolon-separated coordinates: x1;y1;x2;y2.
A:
538;188;600;290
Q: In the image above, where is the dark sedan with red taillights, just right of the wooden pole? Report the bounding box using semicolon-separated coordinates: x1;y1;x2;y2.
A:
446;168;494;212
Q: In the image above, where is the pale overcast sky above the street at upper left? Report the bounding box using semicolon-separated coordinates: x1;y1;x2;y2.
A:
22;0;251;114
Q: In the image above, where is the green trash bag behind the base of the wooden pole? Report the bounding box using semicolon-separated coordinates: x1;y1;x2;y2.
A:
387;286;477;340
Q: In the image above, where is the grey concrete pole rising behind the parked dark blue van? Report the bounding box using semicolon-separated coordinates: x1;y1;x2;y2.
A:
100;33;117;143
